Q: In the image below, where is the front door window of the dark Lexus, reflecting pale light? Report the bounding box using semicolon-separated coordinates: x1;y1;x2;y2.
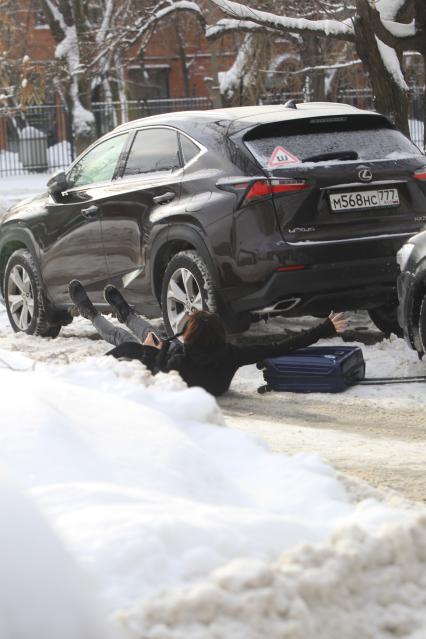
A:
67;133;128;188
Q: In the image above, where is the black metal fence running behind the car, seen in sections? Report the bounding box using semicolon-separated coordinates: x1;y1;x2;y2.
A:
0;87;423;178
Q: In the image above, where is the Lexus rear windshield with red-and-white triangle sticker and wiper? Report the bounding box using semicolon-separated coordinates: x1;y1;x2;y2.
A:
244;116;420;169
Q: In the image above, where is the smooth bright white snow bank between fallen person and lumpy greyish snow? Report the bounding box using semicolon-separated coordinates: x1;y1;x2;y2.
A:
0;351;362;609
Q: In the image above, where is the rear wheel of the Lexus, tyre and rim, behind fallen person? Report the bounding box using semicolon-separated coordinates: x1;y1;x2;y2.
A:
161;251;219;335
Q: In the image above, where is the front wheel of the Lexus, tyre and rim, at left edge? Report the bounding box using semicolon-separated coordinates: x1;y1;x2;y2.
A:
3;249;61;337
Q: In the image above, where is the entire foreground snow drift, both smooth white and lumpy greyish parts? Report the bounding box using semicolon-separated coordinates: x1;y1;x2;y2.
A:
0;336;426;639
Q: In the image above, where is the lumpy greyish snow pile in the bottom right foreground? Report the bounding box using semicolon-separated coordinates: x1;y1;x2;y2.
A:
118;516;426;639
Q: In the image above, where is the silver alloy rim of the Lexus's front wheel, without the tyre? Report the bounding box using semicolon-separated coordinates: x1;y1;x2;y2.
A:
7;264;34;331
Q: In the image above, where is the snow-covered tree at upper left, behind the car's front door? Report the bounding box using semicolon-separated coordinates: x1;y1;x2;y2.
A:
40;0;202;151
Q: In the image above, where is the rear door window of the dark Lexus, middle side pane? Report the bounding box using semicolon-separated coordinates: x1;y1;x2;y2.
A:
123;128;180;177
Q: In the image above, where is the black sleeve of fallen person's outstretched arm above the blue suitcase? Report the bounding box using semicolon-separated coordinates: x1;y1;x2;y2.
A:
234;318;337;366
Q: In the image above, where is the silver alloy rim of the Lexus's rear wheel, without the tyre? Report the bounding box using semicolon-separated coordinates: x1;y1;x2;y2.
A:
167;268;203;333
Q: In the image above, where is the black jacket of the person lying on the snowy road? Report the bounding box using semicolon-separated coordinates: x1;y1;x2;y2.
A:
108;319;336;396
